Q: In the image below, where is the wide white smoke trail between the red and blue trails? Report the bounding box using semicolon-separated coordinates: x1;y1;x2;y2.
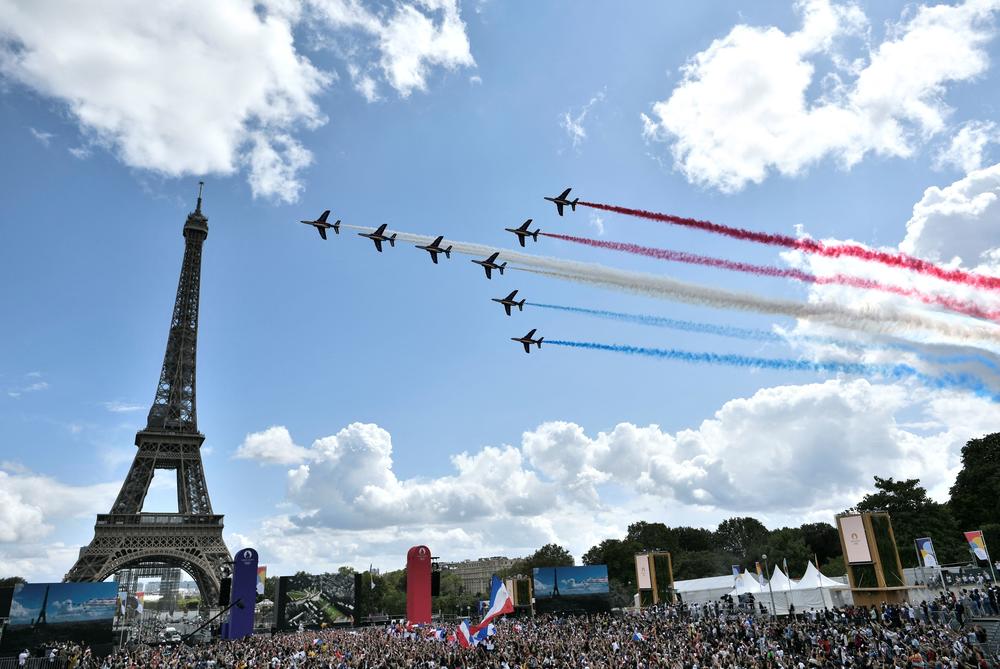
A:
342;225;1000;342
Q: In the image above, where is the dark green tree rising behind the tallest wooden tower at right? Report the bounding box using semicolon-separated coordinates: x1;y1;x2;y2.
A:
856;476;969;567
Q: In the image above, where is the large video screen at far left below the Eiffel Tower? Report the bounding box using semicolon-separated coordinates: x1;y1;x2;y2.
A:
0;582;118;655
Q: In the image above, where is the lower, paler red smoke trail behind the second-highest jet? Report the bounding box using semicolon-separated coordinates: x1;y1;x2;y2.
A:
540;232;1000;322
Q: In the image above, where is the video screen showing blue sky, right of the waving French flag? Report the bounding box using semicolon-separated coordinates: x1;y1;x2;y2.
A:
532;564;611;613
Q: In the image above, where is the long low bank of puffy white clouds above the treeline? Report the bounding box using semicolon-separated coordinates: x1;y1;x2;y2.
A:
247;379;1000;566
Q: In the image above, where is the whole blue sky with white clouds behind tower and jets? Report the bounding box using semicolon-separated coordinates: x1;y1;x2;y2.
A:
0;0;1000;578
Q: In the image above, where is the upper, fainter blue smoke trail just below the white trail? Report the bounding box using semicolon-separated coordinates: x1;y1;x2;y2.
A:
525;302;1000;373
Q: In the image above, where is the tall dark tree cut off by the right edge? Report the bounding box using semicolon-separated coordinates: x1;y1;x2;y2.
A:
951;433;1000;528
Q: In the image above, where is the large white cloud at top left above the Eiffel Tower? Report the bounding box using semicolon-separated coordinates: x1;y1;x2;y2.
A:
0;0;475;202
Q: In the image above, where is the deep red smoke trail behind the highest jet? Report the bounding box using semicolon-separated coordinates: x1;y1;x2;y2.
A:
579;200;1000;290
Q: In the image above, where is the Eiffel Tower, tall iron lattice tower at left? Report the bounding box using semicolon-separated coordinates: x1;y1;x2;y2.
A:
64;183;230;607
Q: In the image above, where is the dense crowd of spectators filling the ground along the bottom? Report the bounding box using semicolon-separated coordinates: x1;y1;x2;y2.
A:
13;593;1000;669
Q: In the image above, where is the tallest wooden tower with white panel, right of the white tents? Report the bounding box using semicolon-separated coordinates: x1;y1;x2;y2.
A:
837;511;907;606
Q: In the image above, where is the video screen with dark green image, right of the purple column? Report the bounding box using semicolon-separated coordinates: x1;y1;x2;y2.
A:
275;574;354;630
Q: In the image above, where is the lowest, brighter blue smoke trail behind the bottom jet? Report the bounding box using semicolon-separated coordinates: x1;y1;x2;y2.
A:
545;339;1000;402
